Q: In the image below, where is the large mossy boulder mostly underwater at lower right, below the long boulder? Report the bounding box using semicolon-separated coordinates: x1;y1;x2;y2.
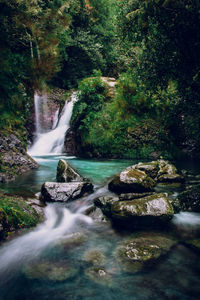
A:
114;234;176;273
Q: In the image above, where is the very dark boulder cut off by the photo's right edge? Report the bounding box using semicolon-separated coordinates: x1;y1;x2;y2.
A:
177;184;200;212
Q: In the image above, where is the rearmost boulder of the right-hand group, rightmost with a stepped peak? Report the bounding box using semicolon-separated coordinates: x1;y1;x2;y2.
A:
157;159;184;183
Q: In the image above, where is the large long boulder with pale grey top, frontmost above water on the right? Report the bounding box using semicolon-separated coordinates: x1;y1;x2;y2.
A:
111;193;174;226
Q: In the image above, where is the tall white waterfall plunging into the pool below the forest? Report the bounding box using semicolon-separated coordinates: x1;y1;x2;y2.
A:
28;92;77;156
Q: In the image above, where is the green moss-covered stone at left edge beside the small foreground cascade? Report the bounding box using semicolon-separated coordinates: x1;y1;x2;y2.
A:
0;194;41;239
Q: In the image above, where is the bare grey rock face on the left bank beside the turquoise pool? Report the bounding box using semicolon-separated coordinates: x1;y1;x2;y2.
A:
0;133;38;182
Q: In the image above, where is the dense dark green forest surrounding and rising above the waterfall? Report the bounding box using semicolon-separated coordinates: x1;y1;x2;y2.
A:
0;0;200;158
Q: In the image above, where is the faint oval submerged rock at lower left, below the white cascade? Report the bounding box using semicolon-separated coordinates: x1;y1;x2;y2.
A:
24;261;78;281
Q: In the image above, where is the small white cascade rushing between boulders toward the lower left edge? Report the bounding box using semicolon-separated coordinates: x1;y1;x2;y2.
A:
0;204;92;275
